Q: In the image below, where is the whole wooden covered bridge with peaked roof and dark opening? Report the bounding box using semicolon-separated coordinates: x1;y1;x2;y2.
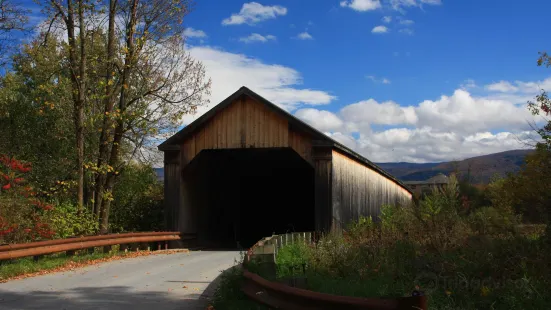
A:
159;87;412;247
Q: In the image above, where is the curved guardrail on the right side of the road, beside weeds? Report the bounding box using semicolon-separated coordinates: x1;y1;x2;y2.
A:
241;233;428;310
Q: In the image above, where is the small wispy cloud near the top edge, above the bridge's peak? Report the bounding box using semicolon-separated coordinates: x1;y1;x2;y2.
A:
222;2;287;25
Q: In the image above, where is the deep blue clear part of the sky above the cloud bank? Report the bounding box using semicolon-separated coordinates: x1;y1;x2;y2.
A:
186;0;551;108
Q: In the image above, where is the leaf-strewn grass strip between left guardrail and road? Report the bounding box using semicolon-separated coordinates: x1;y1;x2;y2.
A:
0;249;128;281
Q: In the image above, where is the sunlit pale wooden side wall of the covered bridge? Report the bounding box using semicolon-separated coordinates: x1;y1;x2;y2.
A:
331;150;412;229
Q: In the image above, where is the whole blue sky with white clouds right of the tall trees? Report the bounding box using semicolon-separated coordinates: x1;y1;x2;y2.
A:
19;0;551;162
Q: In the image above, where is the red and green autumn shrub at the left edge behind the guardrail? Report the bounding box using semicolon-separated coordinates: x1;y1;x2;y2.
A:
0;155;54;243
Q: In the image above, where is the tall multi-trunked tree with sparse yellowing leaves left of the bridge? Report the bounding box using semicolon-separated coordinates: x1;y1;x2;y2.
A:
42;0;210;233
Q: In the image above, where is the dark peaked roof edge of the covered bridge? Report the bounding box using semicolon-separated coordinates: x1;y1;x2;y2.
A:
158;86;411;193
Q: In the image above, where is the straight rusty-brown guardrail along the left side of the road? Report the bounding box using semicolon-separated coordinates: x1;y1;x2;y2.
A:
0;231;195;261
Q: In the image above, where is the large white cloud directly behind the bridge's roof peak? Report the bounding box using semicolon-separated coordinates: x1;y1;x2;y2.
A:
183;46;336;124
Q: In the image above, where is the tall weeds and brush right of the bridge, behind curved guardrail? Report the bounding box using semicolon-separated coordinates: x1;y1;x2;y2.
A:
277;179;551;310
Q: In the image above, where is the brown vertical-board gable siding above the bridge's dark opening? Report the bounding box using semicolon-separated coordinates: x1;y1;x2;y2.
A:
181;97;312;165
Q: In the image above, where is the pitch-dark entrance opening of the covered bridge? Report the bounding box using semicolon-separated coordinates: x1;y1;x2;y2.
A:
180;148;315;248
